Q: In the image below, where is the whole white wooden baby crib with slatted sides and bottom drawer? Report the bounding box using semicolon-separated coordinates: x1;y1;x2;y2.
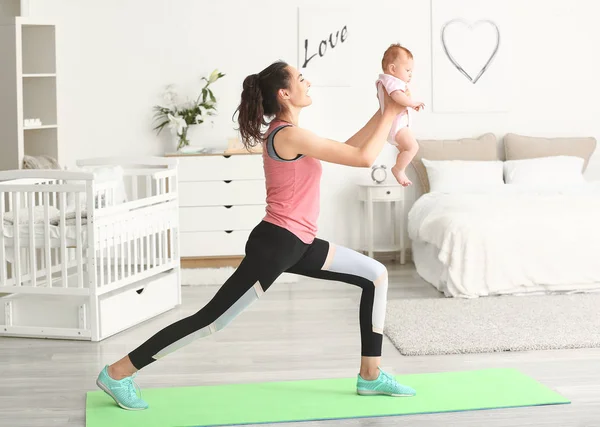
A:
0;157;181;341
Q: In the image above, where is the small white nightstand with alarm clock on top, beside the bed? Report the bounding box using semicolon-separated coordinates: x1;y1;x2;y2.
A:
358;183;406;264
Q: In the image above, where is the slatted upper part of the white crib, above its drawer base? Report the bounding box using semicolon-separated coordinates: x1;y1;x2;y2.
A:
0;159;179;295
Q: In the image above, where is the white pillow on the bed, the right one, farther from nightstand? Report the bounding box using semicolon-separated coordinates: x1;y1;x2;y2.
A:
504;156;586;189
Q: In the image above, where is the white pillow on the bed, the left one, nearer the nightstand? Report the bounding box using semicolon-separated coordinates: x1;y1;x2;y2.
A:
422;159;504;193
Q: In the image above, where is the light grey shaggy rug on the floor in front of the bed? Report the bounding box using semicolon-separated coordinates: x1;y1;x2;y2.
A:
384;294;600;356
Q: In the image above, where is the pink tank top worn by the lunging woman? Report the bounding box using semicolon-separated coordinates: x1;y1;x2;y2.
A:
263;120;322;244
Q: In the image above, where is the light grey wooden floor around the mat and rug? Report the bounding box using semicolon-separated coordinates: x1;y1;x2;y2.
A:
0;264;600;427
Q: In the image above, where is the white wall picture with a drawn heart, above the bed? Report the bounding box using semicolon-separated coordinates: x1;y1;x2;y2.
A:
431;0;512;113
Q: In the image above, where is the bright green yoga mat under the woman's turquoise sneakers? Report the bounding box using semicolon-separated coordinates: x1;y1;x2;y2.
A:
86;369;570;427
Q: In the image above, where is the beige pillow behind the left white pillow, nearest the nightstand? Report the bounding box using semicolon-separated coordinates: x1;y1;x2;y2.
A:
411;133;498;193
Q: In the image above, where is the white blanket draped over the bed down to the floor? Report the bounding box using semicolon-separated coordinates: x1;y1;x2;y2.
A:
408;183;600;297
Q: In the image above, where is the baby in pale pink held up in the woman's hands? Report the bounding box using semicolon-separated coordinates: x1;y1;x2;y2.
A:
375;44;424;187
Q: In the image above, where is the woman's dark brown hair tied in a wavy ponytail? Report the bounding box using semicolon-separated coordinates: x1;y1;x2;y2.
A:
234;61;290;150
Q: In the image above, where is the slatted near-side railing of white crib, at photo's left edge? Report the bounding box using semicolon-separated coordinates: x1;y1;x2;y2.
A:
0;170;93;293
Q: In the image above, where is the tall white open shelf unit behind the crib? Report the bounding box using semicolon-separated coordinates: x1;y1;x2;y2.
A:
0;17;62;170
